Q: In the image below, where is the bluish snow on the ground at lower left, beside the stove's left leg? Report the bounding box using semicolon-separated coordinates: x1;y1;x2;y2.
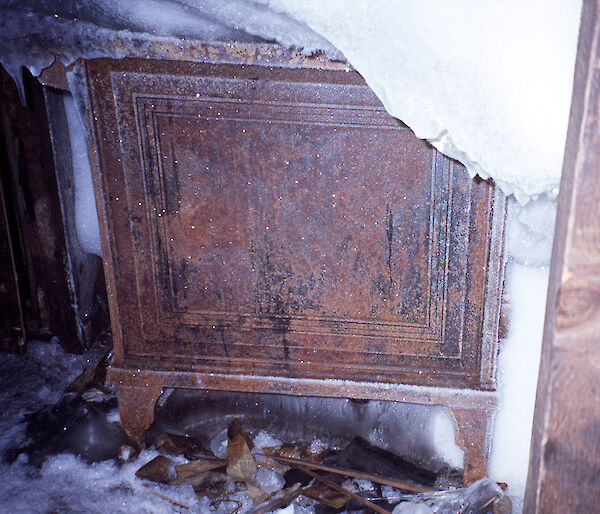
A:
0;341;200;513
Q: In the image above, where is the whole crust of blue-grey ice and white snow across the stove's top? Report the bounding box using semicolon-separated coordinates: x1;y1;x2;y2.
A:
0;0;581;203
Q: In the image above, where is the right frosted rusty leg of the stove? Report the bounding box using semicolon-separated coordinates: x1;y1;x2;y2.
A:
449;407;492;485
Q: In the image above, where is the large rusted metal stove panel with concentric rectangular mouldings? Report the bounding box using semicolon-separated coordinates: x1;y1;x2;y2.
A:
86;45;504;474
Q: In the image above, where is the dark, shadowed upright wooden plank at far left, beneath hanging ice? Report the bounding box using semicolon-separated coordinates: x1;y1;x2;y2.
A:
0;68;81;350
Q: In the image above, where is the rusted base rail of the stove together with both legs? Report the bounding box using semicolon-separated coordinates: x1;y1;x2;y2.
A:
108;367;497;468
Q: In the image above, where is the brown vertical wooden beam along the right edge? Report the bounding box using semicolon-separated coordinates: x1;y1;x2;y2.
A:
524;0;600;513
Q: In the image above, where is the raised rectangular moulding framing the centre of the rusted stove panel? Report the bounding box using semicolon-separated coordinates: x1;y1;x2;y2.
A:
134;90;452;342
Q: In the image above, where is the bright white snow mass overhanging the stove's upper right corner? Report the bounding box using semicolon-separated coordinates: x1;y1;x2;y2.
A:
267;0;581;203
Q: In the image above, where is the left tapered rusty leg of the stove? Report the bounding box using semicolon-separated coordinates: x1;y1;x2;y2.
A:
117;385;162;449
